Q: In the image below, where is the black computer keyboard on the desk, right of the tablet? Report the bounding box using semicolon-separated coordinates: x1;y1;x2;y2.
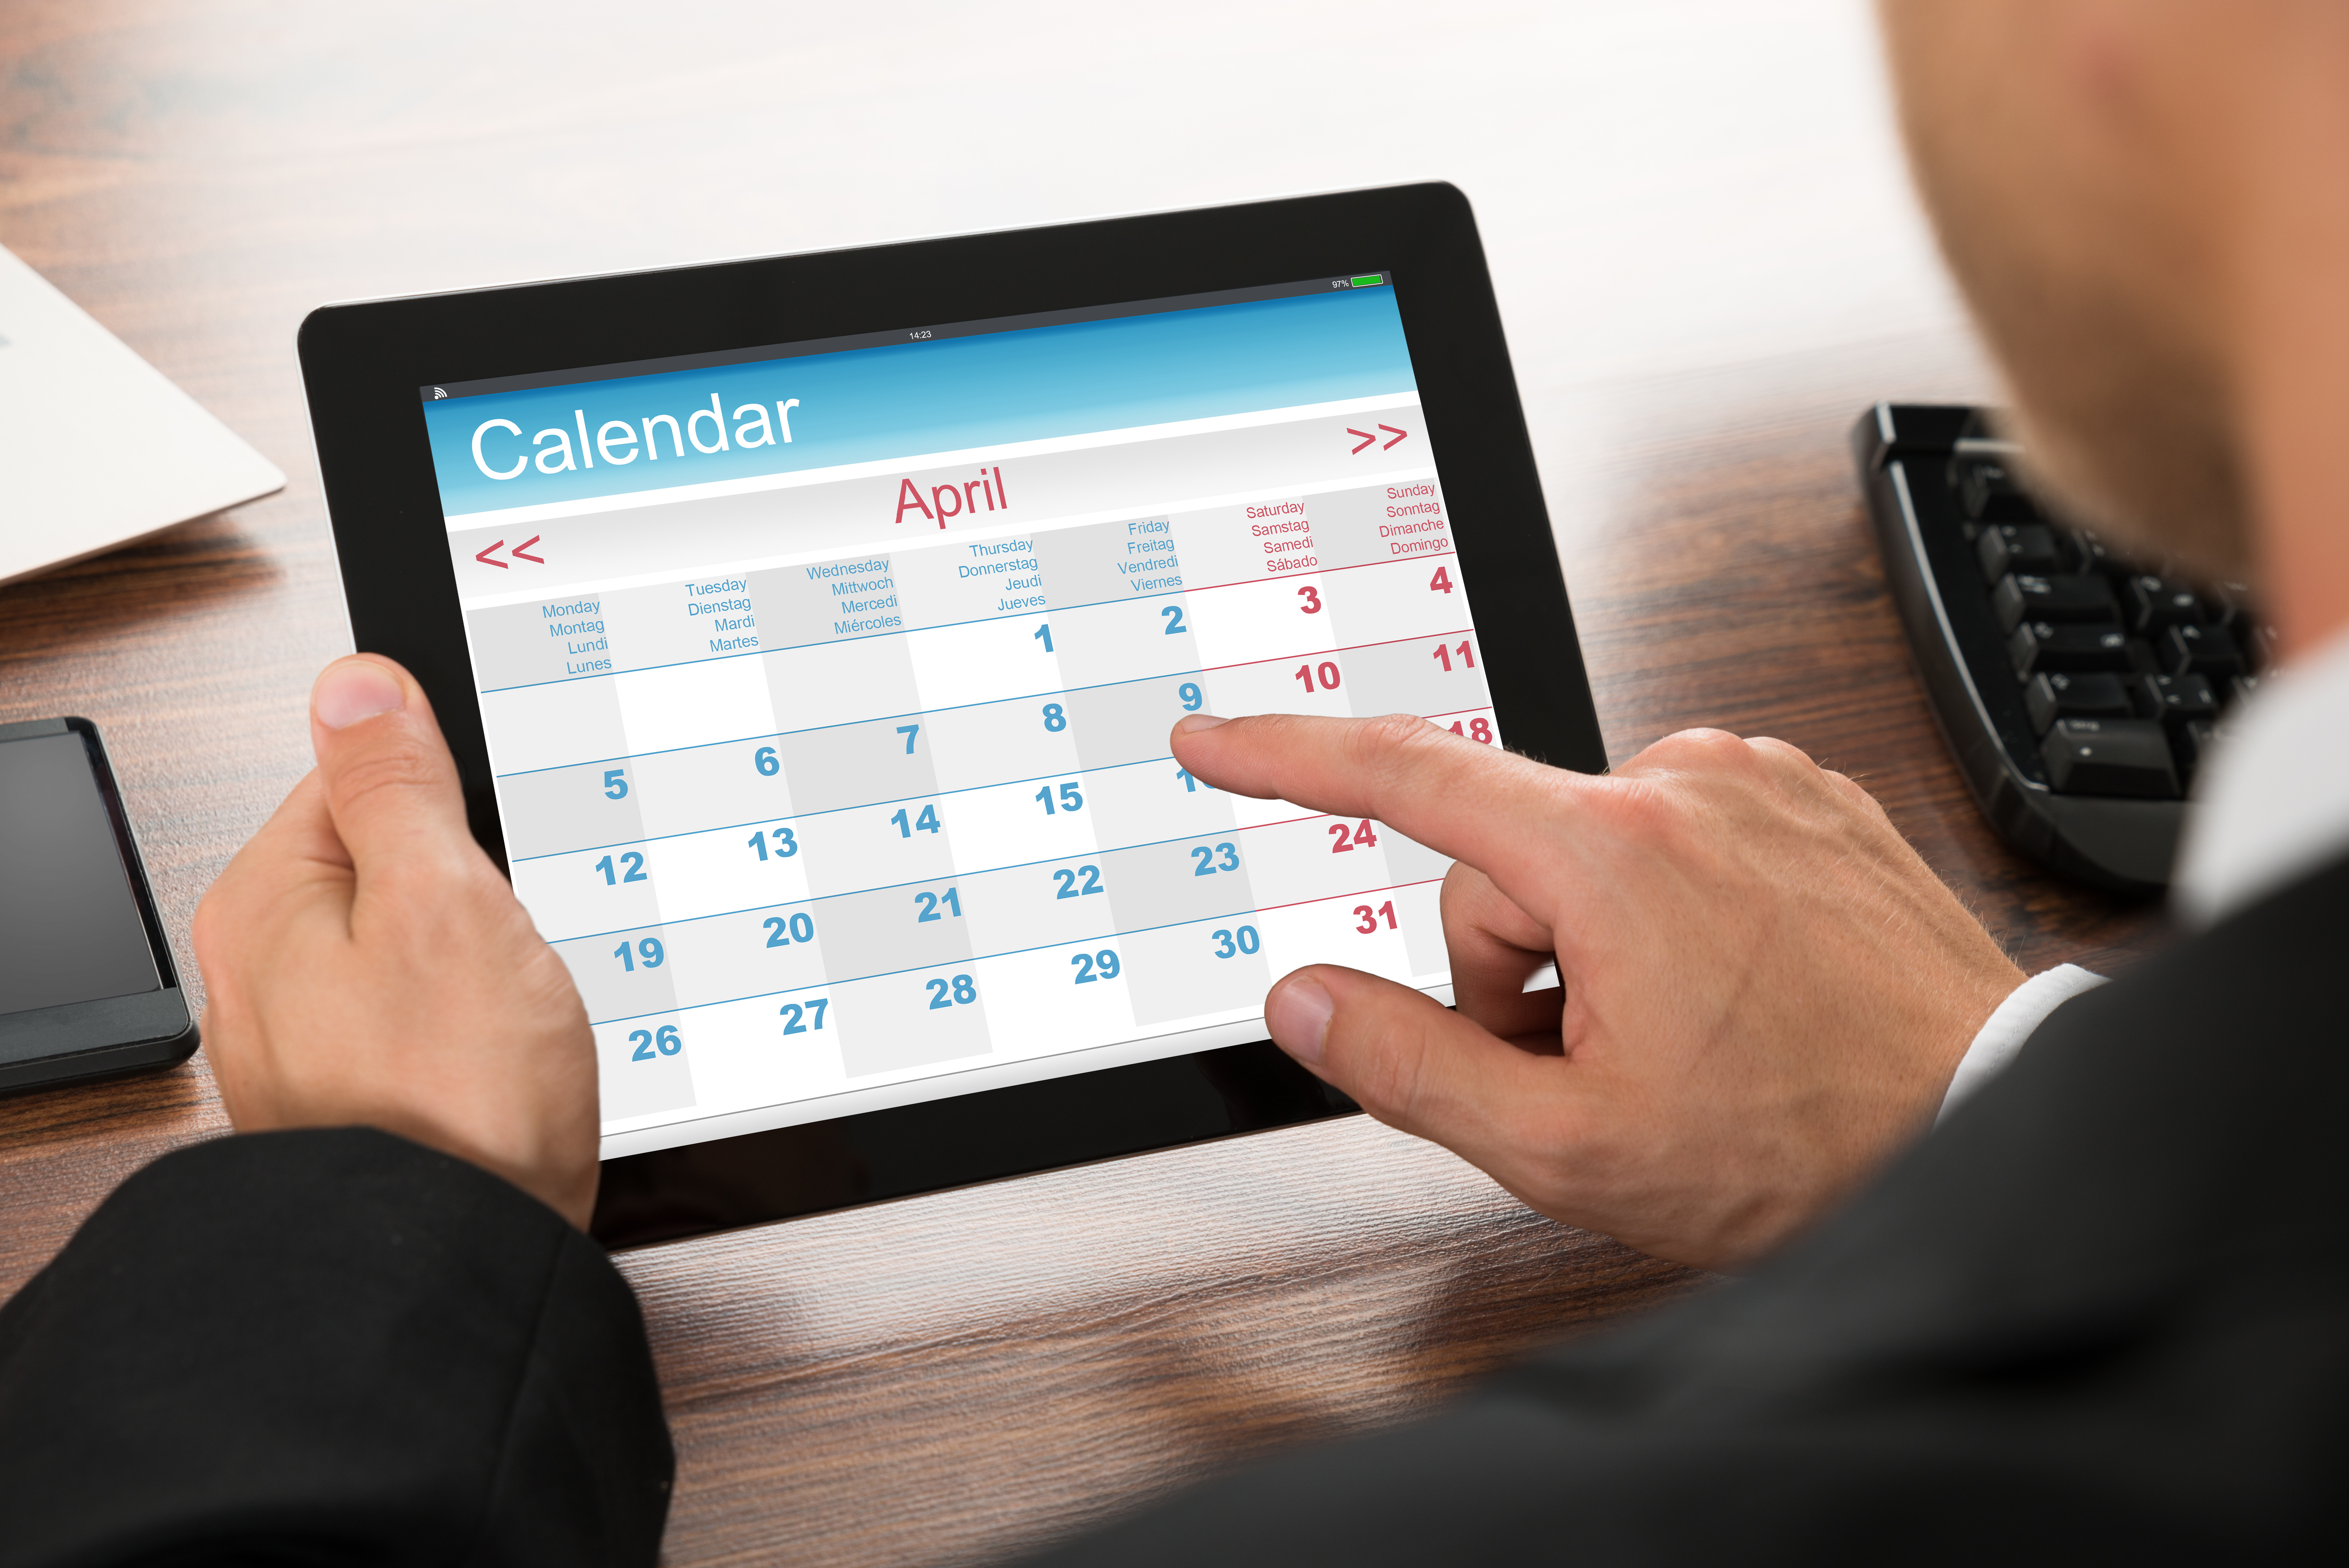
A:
1851;402;2267;893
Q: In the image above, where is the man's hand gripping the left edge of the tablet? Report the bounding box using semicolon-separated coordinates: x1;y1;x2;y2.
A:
195;653;597;1227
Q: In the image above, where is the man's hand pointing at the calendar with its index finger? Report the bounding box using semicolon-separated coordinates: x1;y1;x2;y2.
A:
1175;715;2023;1270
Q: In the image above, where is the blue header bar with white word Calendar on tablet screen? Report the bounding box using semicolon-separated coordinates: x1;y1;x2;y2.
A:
423;287;1419;515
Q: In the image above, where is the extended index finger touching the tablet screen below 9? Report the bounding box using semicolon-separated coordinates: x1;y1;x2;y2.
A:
1175;712;1588;879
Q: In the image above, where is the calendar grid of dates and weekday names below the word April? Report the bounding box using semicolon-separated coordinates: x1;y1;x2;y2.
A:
453;437;1499;1133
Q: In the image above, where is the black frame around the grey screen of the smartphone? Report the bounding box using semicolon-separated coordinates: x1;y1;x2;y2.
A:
0;717;197;1093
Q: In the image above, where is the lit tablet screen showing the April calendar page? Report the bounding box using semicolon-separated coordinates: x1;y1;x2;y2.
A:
423;273;1499;1156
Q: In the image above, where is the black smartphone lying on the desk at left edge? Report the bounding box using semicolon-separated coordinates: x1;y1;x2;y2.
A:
0;719;195;1091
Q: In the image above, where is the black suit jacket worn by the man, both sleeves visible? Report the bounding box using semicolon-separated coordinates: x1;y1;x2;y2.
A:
0;865;2349;1568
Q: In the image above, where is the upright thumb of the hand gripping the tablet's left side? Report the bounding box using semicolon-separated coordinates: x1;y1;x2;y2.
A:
310;653;472;870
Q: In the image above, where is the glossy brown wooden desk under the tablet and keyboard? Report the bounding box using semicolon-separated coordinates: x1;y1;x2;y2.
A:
0;0;2152;1563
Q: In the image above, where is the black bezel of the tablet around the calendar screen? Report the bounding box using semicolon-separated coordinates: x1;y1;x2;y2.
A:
301;183;1607;1246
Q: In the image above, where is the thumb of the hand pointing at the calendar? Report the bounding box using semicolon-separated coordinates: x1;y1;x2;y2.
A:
1264;964;1562;1173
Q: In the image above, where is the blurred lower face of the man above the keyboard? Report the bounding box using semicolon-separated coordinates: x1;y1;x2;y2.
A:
1882;0;2349;602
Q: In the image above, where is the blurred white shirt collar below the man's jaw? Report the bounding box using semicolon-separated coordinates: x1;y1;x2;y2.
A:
2171;630;2349;926
